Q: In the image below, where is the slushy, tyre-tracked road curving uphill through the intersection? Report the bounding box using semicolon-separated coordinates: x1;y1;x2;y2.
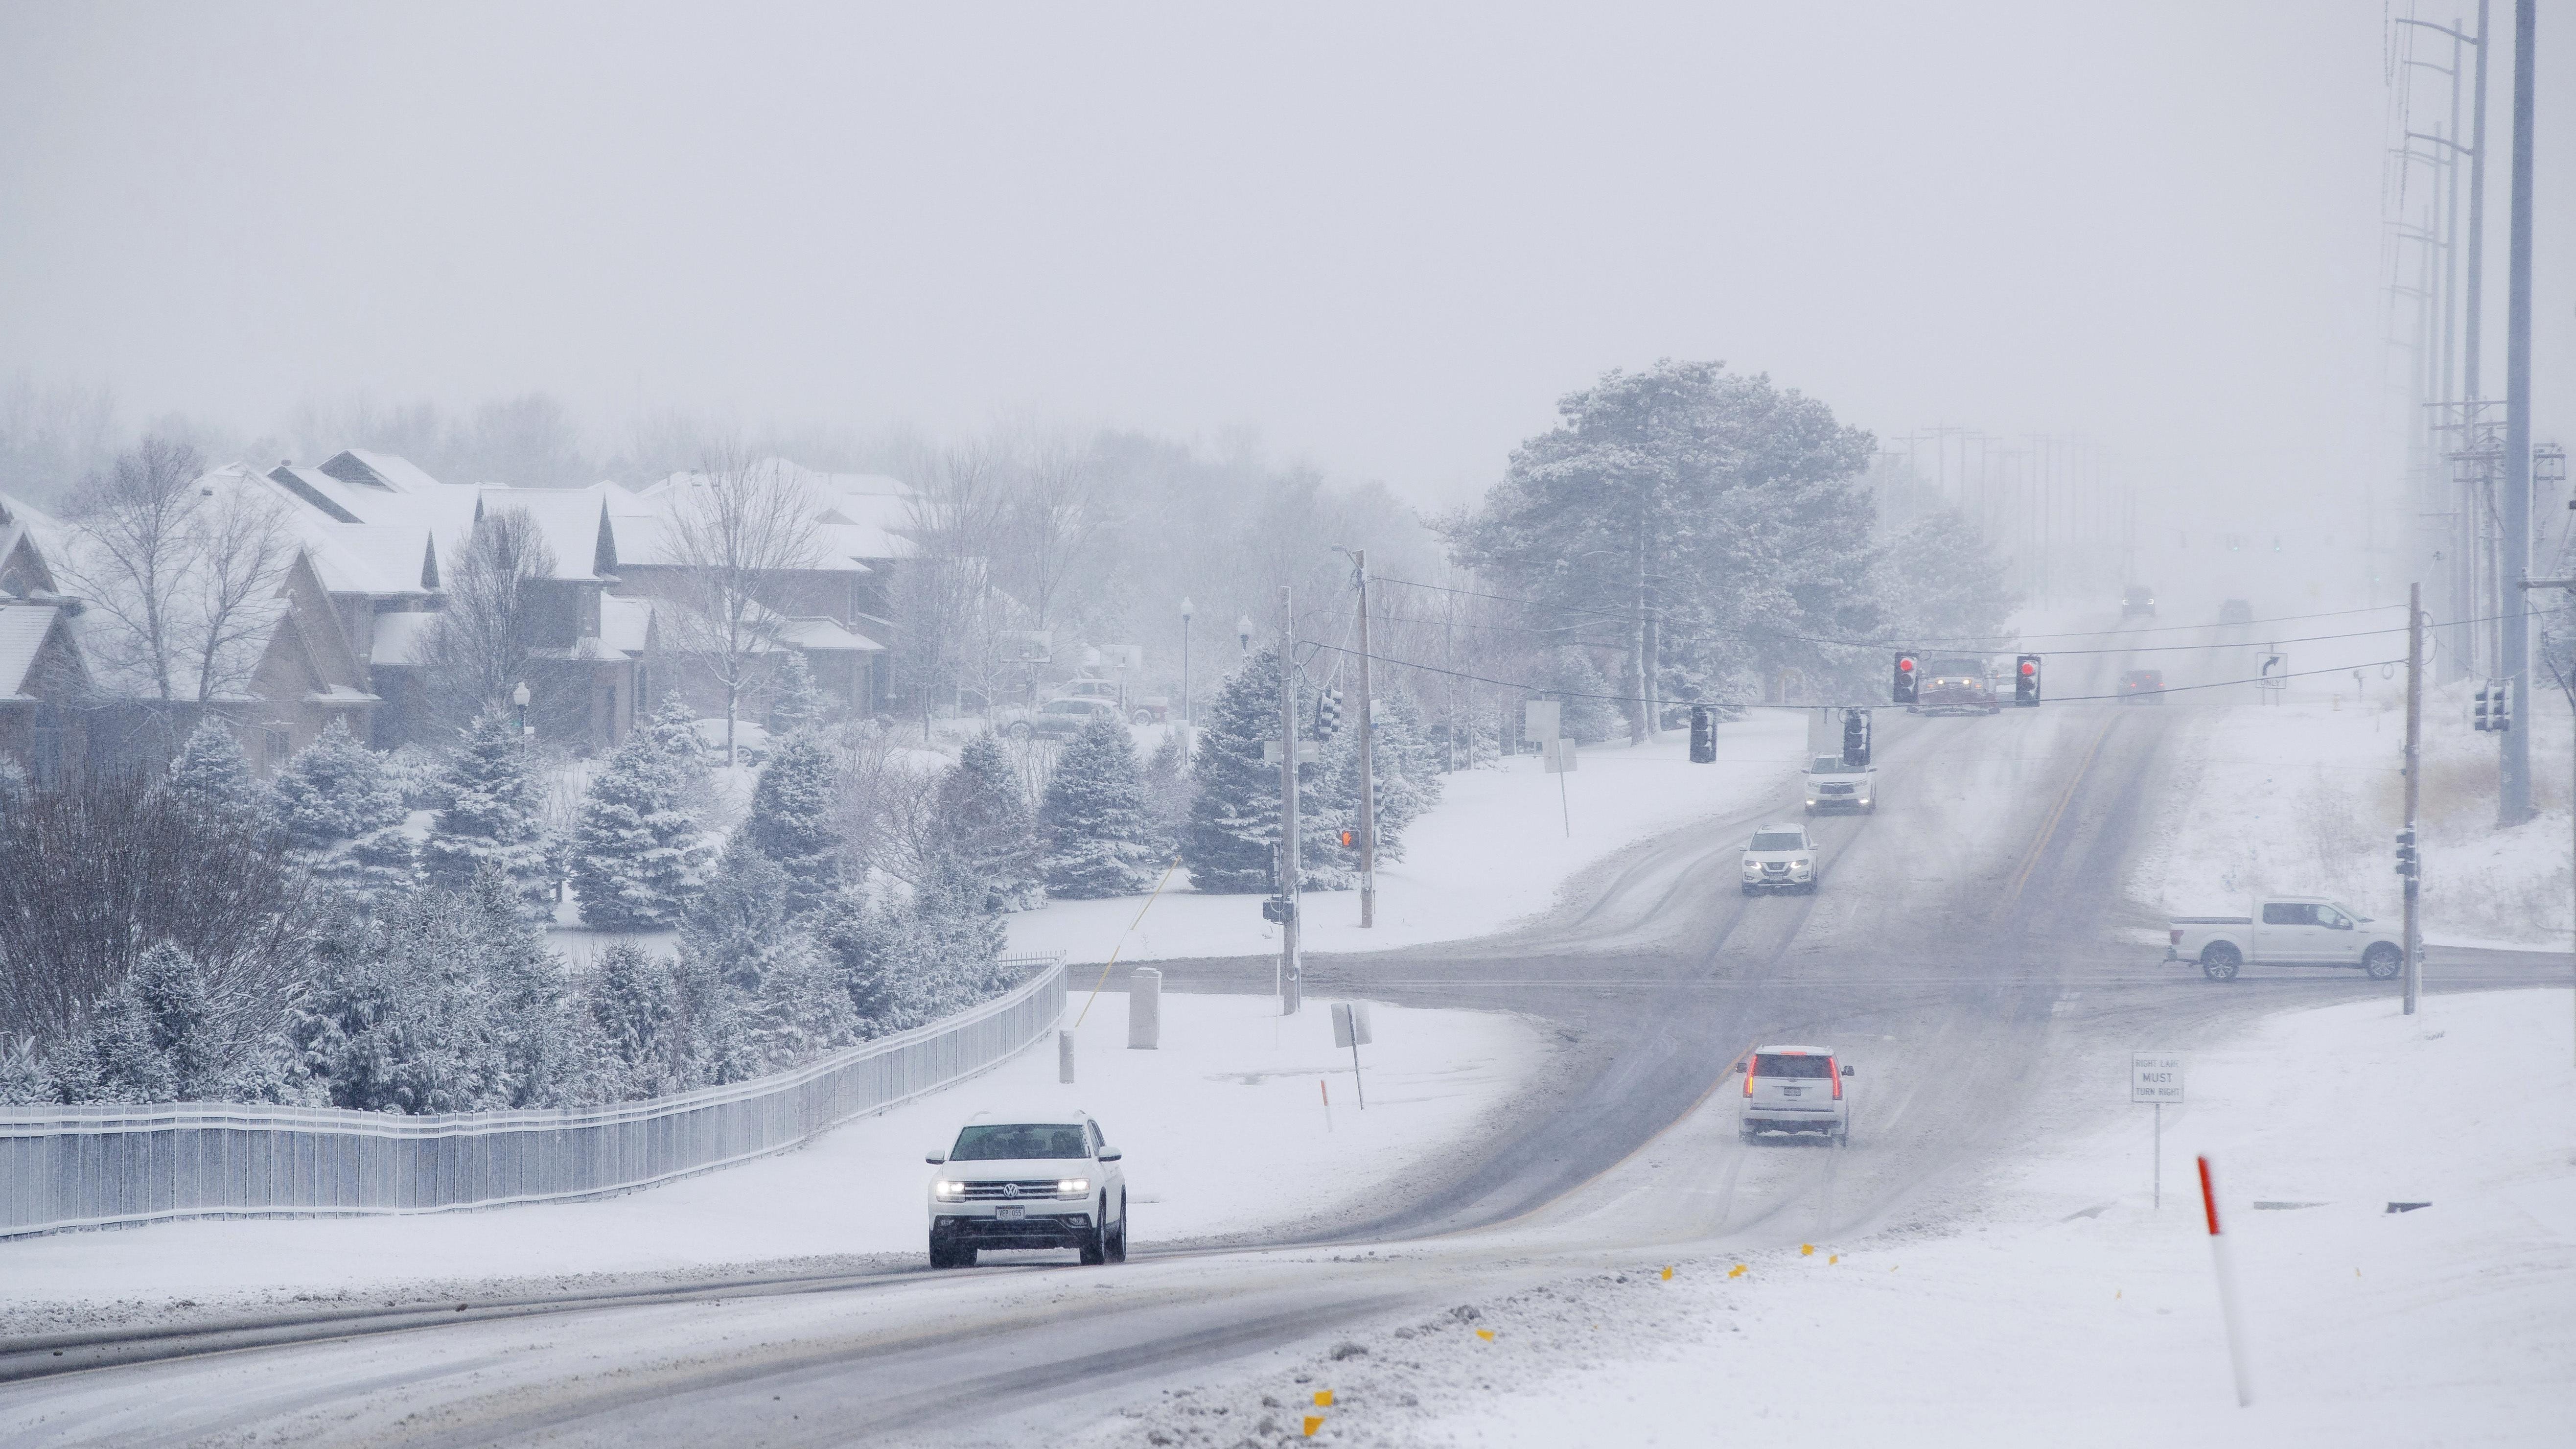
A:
0;629;2563;1447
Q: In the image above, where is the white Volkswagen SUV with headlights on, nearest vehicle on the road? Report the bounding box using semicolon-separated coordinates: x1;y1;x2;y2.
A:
928;1109;1126;1268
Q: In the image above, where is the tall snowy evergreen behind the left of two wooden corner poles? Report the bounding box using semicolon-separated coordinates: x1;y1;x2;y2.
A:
1180;647;1350;895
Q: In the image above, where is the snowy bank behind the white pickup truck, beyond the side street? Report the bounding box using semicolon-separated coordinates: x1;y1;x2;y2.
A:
2131;670;2576;949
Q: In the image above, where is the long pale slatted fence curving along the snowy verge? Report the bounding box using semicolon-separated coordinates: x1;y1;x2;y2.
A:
0;954;1064;1238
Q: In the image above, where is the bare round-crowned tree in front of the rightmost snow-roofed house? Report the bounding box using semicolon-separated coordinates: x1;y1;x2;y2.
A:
657;454;822;766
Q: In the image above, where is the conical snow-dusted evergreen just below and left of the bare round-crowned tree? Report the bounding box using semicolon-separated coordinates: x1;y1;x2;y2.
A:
572;730;716;931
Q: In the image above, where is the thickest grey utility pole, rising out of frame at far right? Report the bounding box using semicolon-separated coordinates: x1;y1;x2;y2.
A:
2496;0;2540;825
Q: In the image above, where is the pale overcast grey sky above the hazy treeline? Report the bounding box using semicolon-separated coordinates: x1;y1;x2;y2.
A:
0;0;2576;500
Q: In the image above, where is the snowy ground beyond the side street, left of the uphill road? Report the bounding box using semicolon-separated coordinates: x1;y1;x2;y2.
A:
1010;709;1806;962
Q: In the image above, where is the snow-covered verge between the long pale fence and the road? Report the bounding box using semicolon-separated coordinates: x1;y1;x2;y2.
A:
0;980;1548;1335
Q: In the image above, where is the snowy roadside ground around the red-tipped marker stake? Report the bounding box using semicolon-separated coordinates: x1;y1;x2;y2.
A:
1082;990;2576;1449
